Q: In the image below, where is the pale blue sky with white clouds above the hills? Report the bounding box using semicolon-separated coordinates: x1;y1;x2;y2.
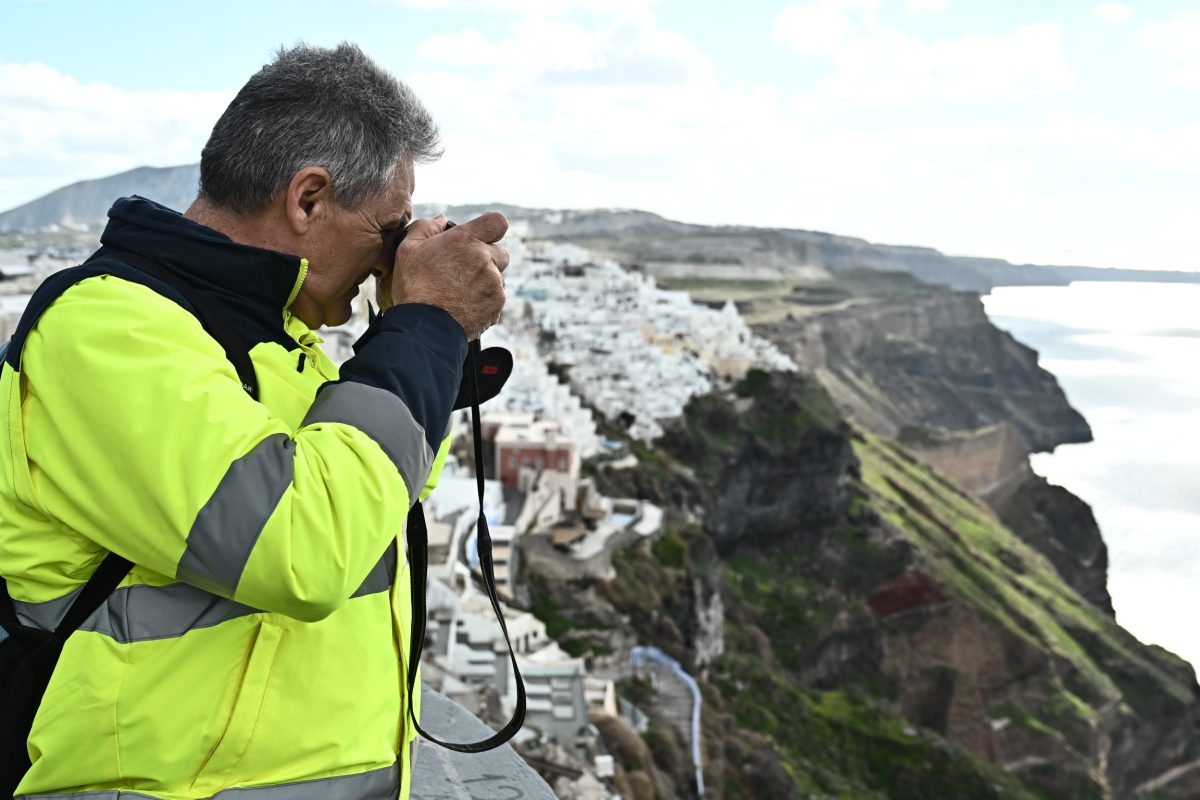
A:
0;0;1200;270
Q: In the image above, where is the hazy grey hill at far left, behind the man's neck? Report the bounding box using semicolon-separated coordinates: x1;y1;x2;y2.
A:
0;164;200;233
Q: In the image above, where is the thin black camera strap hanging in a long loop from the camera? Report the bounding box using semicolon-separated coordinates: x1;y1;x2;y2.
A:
407;339;526;753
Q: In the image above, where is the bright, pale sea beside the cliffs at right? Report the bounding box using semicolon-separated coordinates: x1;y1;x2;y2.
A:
984;282;1200;666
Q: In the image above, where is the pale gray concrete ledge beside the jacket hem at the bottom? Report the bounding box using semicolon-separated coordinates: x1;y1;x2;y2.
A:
412;686;556;800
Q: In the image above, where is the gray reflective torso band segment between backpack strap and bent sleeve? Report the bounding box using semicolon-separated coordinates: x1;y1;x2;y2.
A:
79;583;262;644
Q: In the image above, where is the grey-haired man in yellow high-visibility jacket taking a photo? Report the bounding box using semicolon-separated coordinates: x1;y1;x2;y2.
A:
0;44;508;800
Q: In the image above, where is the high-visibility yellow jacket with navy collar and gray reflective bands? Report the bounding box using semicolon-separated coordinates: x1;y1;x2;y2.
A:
0;198;467;800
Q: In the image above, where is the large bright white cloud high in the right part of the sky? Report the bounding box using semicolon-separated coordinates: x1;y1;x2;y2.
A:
817;24;1075;103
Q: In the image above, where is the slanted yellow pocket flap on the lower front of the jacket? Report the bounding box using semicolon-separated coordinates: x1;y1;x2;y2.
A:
191;622;284;794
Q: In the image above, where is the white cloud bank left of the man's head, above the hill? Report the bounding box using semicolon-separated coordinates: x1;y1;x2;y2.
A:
0;62;233;207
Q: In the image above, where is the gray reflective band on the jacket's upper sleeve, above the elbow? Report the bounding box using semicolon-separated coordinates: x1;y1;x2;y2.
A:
175;433;295;597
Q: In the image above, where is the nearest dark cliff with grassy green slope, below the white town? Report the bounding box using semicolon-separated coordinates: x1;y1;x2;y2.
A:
536;373;1200;798
